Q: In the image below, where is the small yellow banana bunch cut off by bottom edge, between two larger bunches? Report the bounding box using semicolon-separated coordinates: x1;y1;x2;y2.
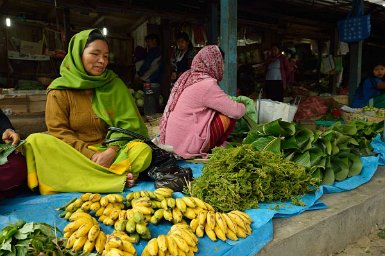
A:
102;231;136;256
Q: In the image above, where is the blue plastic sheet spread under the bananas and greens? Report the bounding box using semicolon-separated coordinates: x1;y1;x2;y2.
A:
0;136;385;256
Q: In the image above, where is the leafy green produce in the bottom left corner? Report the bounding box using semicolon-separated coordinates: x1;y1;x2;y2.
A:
0;220;97;256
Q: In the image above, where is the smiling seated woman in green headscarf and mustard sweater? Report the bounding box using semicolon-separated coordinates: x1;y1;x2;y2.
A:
25;29;152;194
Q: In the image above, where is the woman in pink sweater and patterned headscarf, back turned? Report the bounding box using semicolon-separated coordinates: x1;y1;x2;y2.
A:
160;45;246;159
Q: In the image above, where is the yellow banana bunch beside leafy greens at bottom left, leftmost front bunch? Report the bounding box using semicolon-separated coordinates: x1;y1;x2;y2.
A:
63;211;106;253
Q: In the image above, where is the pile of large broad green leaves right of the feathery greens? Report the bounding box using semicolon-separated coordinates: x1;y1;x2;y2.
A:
243;120;382;184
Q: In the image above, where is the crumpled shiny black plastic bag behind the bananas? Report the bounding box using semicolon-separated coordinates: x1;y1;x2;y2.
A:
148;165;193;192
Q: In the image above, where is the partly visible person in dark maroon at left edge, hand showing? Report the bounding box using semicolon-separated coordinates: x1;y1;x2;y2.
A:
0;109;27;199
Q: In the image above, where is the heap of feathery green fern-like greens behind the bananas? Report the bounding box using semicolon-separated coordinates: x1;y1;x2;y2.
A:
190;145;318;212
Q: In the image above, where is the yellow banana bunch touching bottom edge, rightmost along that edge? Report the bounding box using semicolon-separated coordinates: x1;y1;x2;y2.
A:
142;223;198;256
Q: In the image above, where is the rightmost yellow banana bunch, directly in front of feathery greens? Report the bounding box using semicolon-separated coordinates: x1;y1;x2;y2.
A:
190;210;252;241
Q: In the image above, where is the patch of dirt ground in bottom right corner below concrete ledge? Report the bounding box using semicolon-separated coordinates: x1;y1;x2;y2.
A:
329;227;385;256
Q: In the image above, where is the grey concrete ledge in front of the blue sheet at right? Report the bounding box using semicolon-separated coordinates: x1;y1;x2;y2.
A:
257;167;385;256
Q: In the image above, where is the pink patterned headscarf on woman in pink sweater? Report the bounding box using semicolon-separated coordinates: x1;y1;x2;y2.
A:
160;45;223;144
